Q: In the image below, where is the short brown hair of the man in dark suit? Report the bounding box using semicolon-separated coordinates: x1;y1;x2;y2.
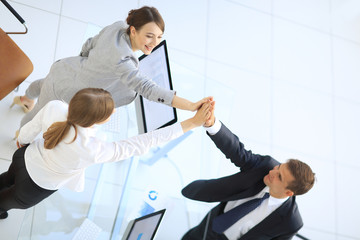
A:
286;159;315;195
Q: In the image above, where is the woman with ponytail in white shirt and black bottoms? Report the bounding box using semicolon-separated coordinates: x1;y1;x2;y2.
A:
0;88;213;219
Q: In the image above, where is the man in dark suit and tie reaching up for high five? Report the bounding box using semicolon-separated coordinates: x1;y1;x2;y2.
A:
182;103;315;240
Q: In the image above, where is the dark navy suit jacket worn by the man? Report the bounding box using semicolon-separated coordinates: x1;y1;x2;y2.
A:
182;124;303;240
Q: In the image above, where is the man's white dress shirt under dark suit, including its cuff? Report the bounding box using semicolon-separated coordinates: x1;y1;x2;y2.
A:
205;119;288;240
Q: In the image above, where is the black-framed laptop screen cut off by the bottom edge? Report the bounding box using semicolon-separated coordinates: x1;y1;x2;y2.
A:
122;209;165;240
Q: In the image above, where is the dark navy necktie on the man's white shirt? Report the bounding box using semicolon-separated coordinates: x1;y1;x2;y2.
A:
212;193;269;233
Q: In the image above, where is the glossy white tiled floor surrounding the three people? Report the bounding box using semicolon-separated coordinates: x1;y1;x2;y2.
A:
0;0;360;240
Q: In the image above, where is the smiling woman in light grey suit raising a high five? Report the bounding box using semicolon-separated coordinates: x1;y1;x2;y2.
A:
12;6;208;127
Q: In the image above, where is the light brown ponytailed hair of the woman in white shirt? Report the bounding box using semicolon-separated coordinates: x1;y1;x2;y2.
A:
43;88;114;149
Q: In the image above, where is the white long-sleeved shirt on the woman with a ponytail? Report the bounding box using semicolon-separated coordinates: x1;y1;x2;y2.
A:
18;100;183;192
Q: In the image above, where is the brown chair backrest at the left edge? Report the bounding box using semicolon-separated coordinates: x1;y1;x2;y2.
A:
0;28;34;100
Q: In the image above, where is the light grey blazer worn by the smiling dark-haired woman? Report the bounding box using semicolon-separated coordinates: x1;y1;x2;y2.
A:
46;22;175;107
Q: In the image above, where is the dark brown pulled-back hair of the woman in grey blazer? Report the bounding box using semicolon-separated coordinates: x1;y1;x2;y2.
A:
126;6;165;35
